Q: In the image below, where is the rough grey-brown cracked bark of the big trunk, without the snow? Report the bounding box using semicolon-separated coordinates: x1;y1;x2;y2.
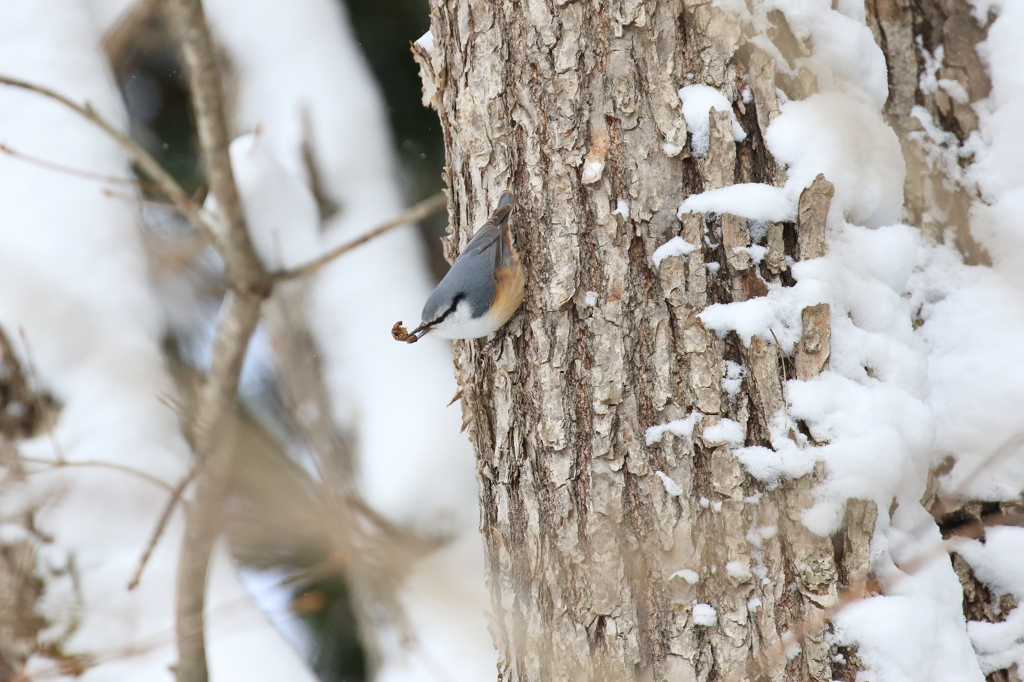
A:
428;0;870;682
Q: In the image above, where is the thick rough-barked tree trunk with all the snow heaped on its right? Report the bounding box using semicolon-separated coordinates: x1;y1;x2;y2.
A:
414;0;1024;681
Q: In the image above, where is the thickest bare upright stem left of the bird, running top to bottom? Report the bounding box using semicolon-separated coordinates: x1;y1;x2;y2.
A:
162;0;273;682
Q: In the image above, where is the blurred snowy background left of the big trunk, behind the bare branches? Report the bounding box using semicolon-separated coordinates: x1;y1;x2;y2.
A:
0;0;496;682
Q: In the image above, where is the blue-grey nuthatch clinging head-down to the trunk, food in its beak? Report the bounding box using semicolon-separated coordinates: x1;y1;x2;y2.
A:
391;191;525;343
